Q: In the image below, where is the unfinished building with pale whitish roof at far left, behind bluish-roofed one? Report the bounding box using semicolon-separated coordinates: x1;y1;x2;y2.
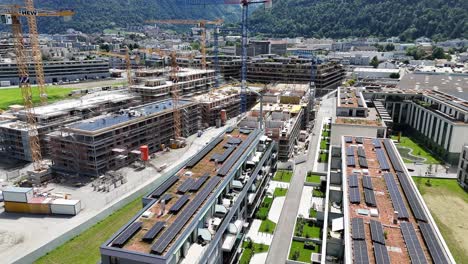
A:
0;92;139;161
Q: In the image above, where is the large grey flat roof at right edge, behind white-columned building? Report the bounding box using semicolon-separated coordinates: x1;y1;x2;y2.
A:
397;73;468;101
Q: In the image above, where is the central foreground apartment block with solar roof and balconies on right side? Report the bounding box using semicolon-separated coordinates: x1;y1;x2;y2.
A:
100;128;276;264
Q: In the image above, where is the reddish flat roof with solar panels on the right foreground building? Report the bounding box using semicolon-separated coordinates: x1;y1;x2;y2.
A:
342;136;453;263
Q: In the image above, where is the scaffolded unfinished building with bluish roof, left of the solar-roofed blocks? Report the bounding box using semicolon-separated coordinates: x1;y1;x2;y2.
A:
50;99;200;176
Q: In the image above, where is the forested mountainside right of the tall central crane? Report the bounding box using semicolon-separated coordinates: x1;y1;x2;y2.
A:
250;0;468;40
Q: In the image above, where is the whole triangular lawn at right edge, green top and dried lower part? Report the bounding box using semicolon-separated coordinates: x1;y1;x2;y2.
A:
413;177;468;263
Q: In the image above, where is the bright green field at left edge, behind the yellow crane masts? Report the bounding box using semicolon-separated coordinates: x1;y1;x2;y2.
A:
0;86;76;110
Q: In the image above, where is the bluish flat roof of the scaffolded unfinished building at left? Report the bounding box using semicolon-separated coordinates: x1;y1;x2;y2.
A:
67;99;192;132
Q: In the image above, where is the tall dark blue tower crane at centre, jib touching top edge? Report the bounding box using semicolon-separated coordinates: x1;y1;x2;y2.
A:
176;0;272;114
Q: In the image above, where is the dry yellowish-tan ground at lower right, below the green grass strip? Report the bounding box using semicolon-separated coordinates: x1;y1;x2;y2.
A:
423;189;468;263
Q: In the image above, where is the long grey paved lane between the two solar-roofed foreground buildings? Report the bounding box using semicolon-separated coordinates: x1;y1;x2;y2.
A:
266;95;336;264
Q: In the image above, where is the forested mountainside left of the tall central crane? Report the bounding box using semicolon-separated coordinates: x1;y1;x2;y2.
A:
5;0;240;33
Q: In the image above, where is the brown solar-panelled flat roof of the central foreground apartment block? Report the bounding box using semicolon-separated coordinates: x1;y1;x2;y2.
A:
108;129;258;256
